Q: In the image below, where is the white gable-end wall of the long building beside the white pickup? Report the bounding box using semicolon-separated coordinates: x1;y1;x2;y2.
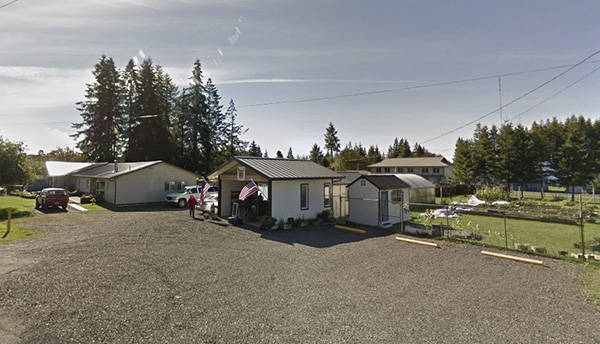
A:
113;163;196;205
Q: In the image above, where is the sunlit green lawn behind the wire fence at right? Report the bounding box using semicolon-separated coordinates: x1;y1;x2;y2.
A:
411;212;600;256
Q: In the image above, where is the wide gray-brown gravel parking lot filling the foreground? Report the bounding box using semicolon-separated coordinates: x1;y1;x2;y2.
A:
0;210;600;343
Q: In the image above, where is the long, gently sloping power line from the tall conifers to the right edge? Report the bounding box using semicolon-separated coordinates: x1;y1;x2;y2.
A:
238;60;600;108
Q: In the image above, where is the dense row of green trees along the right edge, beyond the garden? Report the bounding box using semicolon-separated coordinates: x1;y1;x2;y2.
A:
453;116;600;198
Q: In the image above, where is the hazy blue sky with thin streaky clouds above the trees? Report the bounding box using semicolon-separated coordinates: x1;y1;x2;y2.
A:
0;0;600;158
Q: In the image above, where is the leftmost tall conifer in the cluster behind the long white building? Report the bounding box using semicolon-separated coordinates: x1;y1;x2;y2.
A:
72;55;124;161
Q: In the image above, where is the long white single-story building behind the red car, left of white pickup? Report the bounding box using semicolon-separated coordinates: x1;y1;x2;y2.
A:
46;160;196;205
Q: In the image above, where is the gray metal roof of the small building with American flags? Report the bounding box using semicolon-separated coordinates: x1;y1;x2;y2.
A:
218;156;343;179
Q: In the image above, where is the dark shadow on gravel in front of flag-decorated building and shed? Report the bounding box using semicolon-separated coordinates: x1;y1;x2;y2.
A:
244;226;396;248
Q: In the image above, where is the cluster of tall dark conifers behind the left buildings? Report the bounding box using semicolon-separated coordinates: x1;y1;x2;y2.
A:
72;55;261;174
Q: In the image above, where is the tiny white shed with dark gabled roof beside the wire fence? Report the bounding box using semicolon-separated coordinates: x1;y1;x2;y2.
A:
346;174;410;227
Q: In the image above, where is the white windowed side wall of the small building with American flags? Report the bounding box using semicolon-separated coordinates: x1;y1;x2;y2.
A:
272;179;331;221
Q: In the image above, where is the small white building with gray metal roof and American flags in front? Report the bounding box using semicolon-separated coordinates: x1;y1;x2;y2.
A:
209;156;342;221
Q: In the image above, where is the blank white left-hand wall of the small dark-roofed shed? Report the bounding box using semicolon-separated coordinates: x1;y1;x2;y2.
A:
348;180;379;226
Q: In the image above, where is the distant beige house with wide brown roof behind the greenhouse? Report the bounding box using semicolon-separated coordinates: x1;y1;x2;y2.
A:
368;156;454;185
